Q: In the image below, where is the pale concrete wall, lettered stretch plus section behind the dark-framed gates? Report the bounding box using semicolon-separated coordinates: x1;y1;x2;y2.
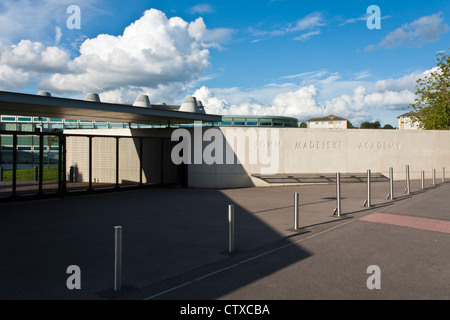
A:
65;127;450;188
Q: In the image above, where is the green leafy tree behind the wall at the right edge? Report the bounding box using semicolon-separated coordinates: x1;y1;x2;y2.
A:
408;52;450;130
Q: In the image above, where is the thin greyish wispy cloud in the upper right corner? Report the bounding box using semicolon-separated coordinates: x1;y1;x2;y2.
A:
366;13;450;50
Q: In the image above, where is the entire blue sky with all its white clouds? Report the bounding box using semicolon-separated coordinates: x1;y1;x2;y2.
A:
0;0;450;126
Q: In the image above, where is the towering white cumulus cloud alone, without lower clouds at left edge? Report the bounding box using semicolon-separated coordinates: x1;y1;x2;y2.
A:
35;9;228;92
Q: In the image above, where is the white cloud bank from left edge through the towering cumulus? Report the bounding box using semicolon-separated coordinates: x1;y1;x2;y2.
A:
0;9;234;103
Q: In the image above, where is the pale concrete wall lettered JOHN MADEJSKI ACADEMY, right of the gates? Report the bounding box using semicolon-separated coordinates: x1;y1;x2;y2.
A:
188;127;450;188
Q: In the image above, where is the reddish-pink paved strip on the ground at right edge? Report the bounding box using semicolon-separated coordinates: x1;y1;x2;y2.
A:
360;213;450;233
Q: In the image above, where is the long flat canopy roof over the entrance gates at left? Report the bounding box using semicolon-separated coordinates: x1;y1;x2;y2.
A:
0;91;222;125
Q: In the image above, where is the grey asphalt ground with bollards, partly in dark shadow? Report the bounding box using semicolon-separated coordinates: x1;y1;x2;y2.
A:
0;180;450;301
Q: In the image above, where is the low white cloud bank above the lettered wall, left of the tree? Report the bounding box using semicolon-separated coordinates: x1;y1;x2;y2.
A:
193;70;427;125
